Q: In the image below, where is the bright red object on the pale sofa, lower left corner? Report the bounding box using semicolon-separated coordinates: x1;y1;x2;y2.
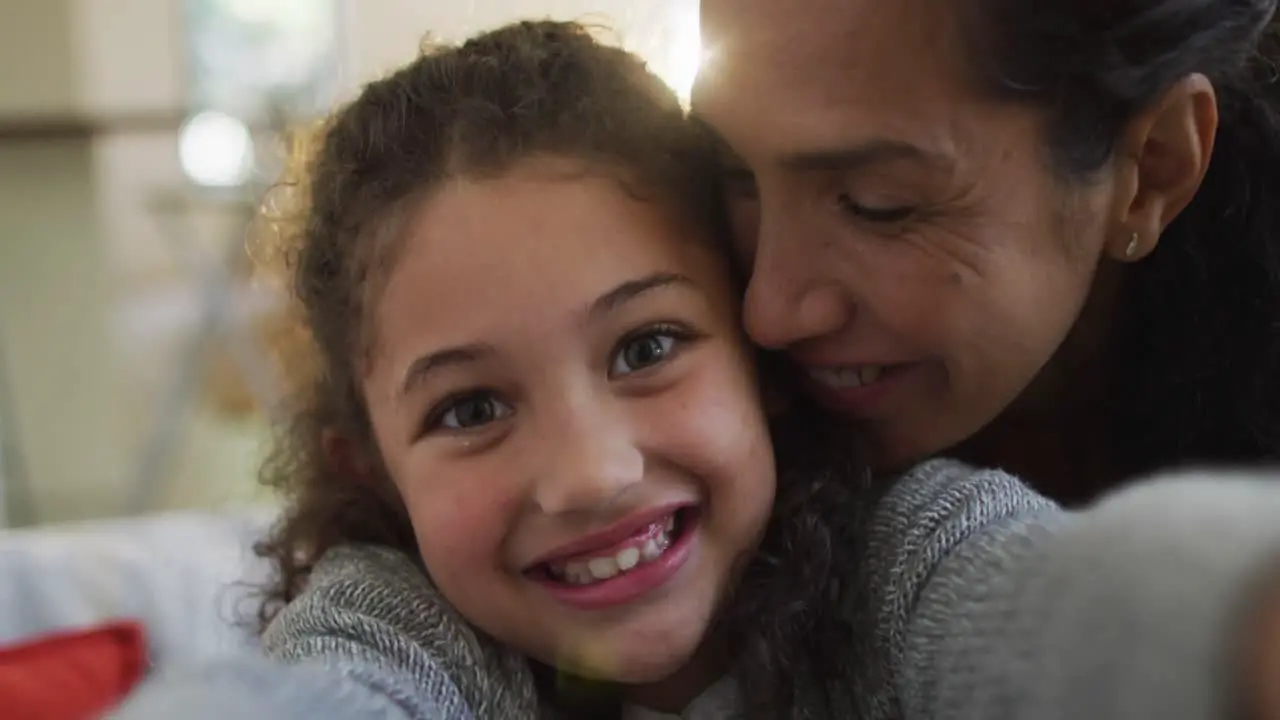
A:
0;621;147;720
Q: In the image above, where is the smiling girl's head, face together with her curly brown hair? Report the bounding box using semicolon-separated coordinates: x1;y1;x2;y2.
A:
245;23;855;716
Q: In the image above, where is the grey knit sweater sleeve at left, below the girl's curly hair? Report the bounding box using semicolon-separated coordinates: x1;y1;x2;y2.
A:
104;546;538;720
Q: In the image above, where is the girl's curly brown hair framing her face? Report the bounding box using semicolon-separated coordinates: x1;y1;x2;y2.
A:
251;22;863;716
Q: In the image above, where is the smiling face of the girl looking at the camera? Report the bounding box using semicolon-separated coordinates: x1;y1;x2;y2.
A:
364;159;774;683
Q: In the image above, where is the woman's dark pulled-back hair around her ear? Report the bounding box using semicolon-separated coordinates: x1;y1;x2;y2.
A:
966;0;1280;493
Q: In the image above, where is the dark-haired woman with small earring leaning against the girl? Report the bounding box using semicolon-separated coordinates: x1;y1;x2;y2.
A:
694;0;1280;503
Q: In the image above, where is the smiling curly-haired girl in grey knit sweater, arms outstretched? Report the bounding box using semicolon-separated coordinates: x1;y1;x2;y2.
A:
112;16;1280;720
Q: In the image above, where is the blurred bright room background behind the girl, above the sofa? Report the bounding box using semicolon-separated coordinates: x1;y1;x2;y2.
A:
0;0;699;528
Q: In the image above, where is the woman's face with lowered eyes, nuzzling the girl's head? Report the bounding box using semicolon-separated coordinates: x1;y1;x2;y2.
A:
694;0;1116;466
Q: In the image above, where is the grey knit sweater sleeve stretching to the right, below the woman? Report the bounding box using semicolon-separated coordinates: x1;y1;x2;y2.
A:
885;461;1280;720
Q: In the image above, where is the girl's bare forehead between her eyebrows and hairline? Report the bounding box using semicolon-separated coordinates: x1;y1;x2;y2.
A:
374;167;735;371
